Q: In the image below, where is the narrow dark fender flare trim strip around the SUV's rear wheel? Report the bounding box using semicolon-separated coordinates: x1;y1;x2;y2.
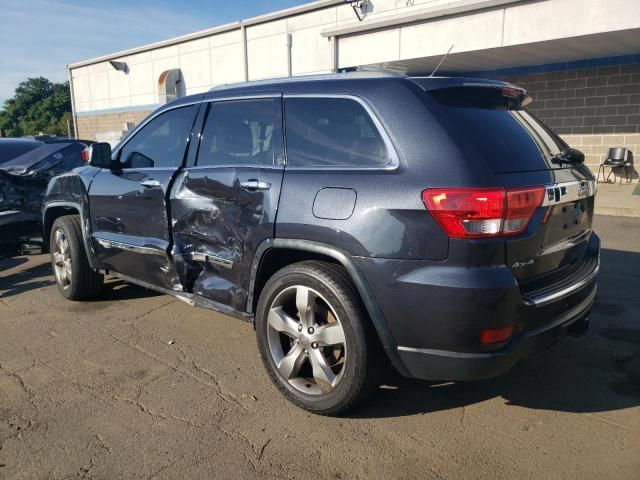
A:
247;238;409;376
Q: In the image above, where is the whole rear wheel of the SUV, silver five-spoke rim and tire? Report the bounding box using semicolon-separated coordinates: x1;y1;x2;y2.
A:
256;261;383;415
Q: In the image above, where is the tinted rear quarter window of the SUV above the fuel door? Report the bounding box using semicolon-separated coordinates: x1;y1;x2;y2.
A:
285;98;389;167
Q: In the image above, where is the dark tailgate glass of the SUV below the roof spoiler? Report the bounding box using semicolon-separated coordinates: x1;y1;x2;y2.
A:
427;87;567;173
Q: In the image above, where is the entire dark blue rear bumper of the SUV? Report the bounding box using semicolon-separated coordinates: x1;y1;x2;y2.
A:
357;234;600;380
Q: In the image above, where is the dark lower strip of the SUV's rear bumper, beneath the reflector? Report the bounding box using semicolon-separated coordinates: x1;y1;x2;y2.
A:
398;282;597;381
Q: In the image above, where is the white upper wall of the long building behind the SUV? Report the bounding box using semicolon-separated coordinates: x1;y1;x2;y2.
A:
71;0;640;114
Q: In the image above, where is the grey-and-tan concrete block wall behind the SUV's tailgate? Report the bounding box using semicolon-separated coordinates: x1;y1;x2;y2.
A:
502;63;640;171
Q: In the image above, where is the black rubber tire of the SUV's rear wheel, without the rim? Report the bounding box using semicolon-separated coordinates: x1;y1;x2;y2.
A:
256;261;386;416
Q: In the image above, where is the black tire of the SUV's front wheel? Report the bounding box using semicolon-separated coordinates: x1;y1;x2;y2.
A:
49;215;104;300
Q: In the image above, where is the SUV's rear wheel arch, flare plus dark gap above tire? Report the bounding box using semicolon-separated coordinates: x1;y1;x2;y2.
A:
247;238;407;375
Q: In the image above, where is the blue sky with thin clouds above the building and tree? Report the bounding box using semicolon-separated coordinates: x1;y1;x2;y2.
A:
0;0;309;106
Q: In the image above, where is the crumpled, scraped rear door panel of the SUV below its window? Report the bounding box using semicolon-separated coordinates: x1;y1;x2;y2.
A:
171;167;283;312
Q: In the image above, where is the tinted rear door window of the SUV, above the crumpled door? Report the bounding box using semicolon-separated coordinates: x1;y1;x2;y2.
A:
197;98;283;166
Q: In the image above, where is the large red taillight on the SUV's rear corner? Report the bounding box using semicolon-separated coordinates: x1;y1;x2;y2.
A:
422;187;544;238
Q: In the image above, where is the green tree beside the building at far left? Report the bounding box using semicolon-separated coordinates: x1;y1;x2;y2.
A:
0;77;71;137
